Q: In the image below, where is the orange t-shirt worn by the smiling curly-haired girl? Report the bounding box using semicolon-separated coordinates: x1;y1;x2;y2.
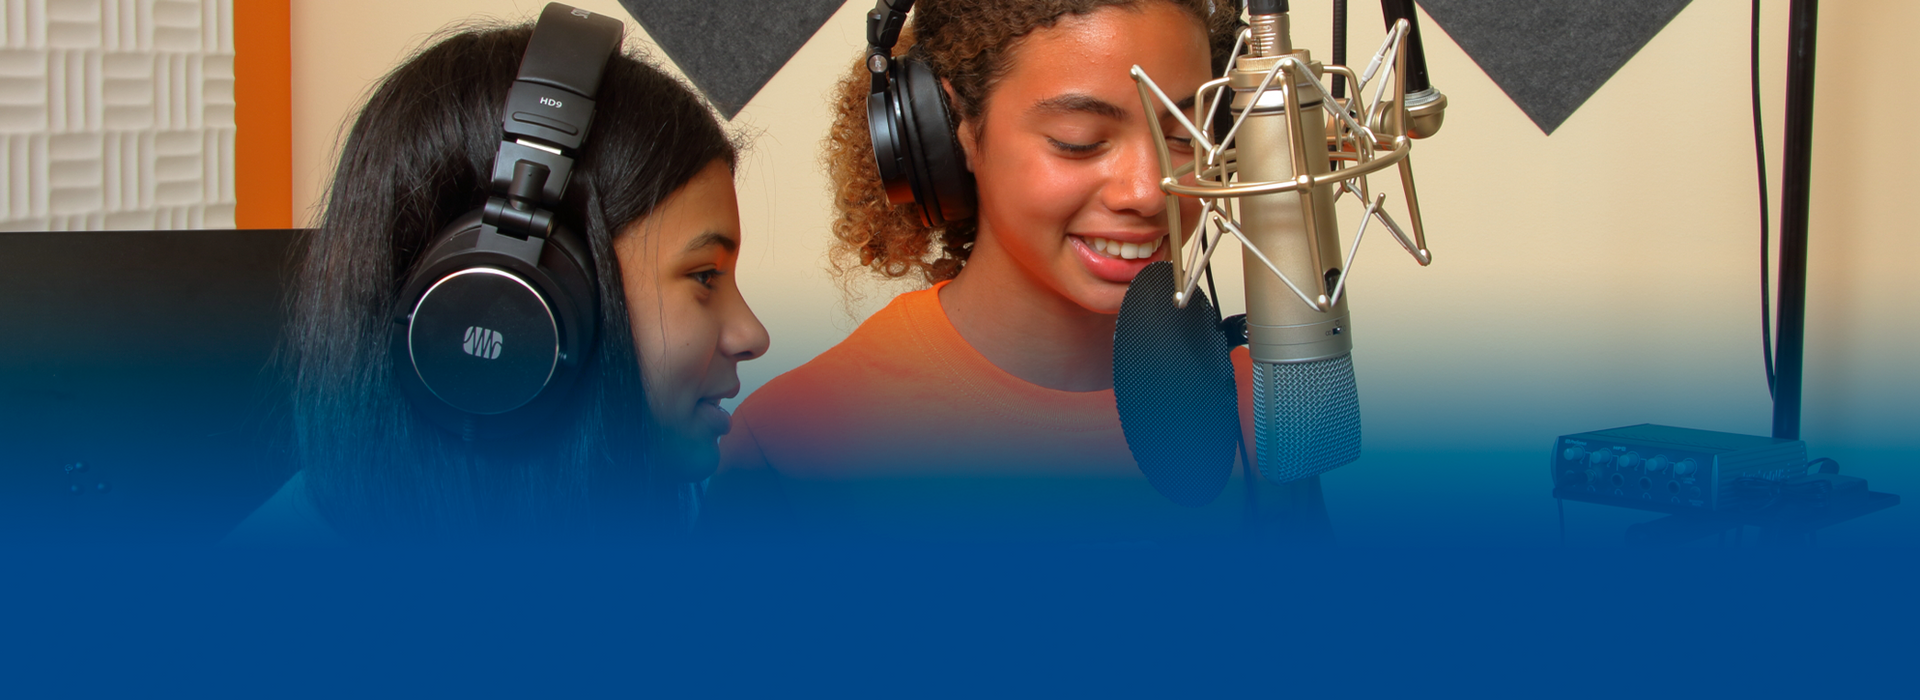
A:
703;286;1290;541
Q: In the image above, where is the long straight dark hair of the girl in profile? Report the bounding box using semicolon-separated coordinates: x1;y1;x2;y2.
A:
288;25;737;541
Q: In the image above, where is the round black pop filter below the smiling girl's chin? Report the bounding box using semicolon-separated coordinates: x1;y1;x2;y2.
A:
1114;261;1240;506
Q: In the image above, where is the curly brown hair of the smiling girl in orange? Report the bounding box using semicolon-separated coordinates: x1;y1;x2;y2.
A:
822;0;1240;285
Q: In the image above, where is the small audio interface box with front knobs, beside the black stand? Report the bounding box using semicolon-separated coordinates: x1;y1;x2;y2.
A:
1551;424;1807;512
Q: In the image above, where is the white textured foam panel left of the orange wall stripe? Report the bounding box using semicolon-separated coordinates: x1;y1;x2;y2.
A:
0;0;234;230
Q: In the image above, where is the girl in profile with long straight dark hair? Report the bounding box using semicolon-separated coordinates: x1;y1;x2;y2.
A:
230;16;768;543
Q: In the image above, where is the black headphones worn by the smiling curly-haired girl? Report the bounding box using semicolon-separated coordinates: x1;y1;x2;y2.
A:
866;0;975;226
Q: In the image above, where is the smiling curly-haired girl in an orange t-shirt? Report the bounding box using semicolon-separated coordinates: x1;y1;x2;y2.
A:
712;0;1313;541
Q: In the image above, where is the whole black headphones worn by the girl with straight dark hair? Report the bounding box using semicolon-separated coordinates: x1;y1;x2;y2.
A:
392;4;622;439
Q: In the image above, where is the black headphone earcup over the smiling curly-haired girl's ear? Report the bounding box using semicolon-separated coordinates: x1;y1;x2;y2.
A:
887;56;975;226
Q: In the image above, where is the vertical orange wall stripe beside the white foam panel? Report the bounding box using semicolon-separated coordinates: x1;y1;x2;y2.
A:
234;0;294;228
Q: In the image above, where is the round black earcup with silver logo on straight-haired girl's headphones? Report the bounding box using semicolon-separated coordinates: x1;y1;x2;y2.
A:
390;209;599;435
